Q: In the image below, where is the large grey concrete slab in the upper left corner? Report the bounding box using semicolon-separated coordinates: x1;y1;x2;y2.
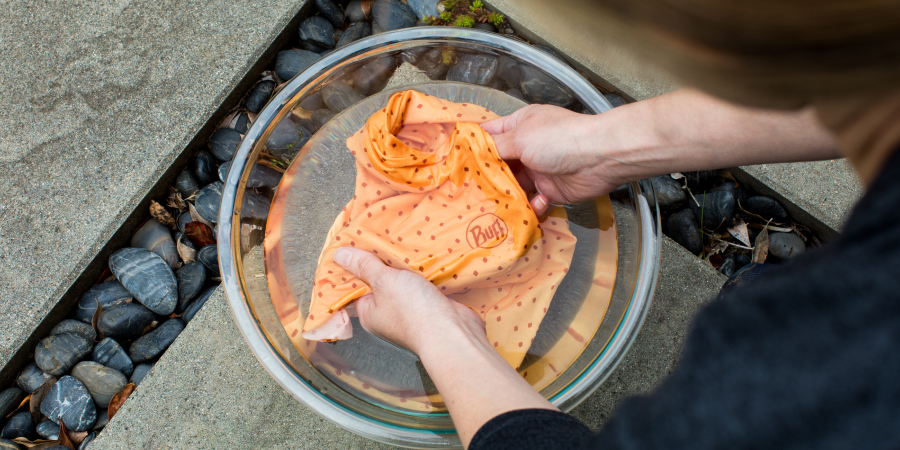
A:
0;0;305;367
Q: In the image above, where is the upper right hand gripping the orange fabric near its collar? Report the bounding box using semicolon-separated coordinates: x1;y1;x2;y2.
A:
481;105;627;216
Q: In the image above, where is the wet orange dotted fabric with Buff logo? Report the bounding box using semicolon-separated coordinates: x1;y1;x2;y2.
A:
302;91;575;367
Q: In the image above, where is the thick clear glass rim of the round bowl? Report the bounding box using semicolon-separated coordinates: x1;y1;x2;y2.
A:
217;27;660;448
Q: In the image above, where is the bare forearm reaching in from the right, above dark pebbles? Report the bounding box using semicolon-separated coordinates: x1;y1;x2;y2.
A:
586;89;841;181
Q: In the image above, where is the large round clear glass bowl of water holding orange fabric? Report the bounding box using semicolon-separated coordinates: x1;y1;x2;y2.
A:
218;27;659;448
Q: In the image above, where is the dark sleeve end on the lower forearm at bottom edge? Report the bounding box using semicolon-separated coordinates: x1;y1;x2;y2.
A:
469;409;593;450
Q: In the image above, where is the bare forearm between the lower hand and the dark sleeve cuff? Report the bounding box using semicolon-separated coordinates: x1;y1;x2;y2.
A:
417;318;556;447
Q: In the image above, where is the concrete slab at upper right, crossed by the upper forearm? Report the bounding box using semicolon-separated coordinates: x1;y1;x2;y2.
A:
488;0;863;234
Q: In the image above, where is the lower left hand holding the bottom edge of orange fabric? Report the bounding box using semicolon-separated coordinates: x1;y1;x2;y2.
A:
334;247;484;354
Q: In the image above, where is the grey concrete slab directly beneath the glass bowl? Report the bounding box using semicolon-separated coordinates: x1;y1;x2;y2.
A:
91;238;725;450
